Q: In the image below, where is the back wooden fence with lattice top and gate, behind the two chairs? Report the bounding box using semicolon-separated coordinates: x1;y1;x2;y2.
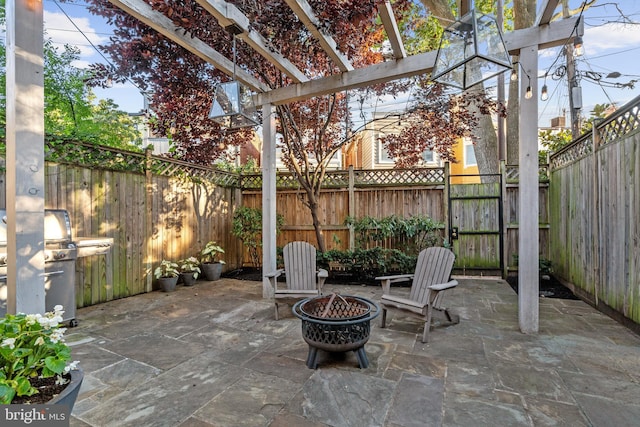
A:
241;162;549;274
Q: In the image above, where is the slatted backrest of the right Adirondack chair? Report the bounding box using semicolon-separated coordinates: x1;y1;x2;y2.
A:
409;247;456;304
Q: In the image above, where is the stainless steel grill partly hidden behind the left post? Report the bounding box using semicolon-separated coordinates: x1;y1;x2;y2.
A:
0;209;113;326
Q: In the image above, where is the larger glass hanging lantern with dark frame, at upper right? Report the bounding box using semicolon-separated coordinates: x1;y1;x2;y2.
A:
431;10;511;90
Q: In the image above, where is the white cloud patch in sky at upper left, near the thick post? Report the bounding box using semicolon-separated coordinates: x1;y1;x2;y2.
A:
44;10;108;66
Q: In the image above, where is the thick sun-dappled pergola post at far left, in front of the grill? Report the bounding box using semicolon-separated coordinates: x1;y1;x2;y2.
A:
6;0;45;313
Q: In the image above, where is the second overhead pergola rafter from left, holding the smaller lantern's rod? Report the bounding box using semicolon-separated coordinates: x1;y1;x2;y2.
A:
196;0;309;83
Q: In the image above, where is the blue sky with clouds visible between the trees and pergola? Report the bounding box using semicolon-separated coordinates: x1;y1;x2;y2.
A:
44;0;640;127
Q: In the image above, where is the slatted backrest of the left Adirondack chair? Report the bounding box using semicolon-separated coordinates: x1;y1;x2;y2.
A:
282;242;317;290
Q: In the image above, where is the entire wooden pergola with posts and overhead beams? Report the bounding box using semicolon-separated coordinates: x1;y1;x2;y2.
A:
6;0;583;333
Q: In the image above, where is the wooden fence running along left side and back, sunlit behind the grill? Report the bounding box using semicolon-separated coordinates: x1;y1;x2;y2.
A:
0;142;548;307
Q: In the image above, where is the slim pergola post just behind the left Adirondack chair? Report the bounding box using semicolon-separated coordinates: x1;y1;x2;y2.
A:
262;104;276;298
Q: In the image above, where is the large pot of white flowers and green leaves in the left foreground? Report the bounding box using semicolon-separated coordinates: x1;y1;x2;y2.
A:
0;305;84;408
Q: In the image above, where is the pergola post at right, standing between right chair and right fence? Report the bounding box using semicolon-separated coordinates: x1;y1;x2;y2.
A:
518;45;540;334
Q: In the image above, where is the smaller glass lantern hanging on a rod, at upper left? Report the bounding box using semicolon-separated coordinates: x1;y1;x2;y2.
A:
209;26;260;129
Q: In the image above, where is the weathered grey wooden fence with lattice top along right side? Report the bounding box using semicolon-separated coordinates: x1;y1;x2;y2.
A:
549;97;640;324
